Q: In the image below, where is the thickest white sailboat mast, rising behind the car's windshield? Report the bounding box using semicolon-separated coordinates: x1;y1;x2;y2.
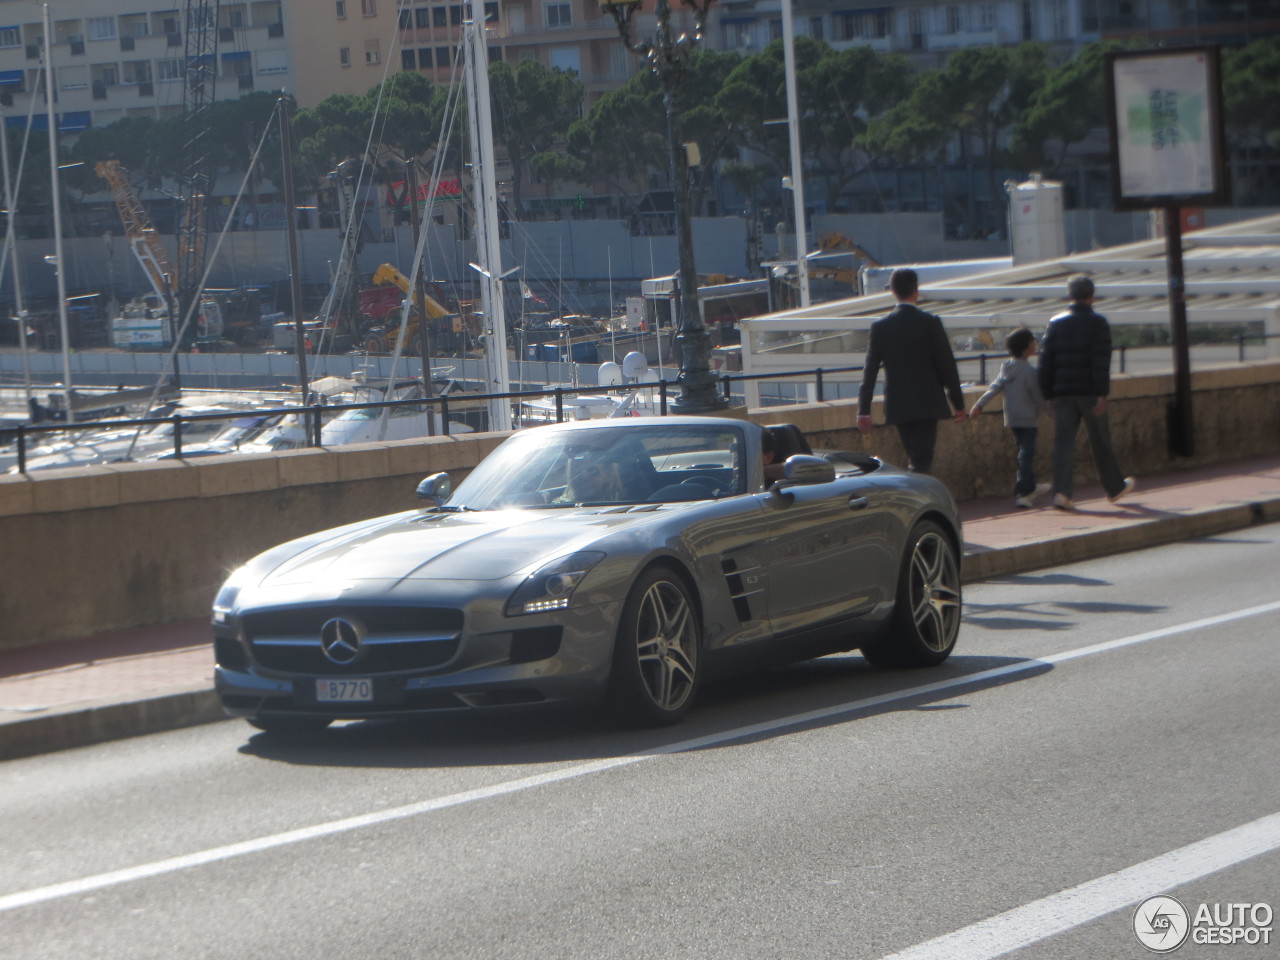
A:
466;0;511;430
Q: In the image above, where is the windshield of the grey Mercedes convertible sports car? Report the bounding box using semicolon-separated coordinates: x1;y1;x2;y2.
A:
448;421;746;509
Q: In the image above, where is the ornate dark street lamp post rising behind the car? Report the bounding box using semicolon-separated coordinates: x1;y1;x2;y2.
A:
600;0;728;413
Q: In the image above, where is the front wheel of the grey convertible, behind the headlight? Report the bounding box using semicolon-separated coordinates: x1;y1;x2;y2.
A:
608;567;701;727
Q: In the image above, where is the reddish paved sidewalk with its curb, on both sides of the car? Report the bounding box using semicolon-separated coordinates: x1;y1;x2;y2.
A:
0;456;1280;759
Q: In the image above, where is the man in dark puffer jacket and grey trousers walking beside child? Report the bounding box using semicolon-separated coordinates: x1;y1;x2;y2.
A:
1039;274;1134;509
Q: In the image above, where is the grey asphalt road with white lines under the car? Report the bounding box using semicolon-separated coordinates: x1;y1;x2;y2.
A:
0;526;1280;960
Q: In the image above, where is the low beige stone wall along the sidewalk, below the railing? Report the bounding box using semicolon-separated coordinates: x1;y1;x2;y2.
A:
0;362;1280;648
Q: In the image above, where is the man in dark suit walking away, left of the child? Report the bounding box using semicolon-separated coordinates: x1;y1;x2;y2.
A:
858;266;968;474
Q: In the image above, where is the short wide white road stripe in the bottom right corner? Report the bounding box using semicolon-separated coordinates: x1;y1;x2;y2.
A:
883;813;1280;960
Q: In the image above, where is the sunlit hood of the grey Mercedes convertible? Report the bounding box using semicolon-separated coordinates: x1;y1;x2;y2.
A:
260;508;652;588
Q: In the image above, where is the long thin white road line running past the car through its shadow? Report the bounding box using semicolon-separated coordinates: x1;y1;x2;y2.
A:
0;600;1280;913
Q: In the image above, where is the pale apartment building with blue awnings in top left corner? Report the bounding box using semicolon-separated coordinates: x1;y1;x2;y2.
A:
0;0;292;133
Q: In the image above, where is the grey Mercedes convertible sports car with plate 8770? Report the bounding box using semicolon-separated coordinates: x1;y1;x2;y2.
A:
214;417;961;732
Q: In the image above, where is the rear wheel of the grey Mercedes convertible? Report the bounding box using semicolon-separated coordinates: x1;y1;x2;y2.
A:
863;520;961;667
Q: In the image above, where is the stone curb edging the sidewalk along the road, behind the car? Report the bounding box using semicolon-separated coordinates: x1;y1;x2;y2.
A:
0;498;1280;760
